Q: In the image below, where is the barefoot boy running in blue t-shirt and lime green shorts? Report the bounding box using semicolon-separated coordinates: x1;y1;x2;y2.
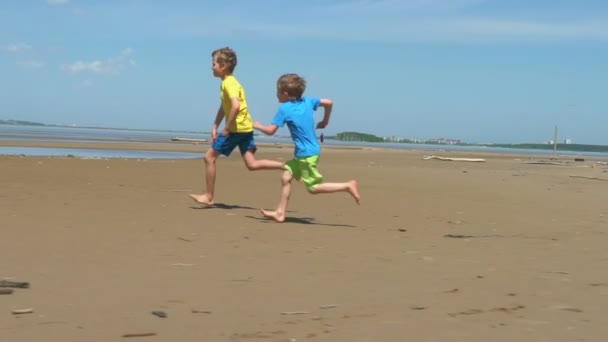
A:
253;74;361;222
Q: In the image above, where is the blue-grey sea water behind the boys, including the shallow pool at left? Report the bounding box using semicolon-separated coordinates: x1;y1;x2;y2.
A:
0;124;608;159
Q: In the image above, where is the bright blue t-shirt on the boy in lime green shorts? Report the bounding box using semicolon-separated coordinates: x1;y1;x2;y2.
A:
272;97;321;158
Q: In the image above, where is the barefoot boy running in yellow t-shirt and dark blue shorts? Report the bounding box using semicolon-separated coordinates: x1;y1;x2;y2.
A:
189;47;284;205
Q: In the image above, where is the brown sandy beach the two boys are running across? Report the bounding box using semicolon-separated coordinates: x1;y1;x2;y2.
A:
0;142;608;342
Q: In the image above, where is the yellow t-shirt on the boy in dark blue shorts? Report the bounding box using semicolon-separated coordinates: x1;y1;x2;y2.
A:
220;75;253;133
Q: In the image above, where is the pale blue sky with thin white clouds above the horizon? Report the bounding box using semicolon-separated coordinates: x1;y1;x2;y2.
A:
0;0;608;145
